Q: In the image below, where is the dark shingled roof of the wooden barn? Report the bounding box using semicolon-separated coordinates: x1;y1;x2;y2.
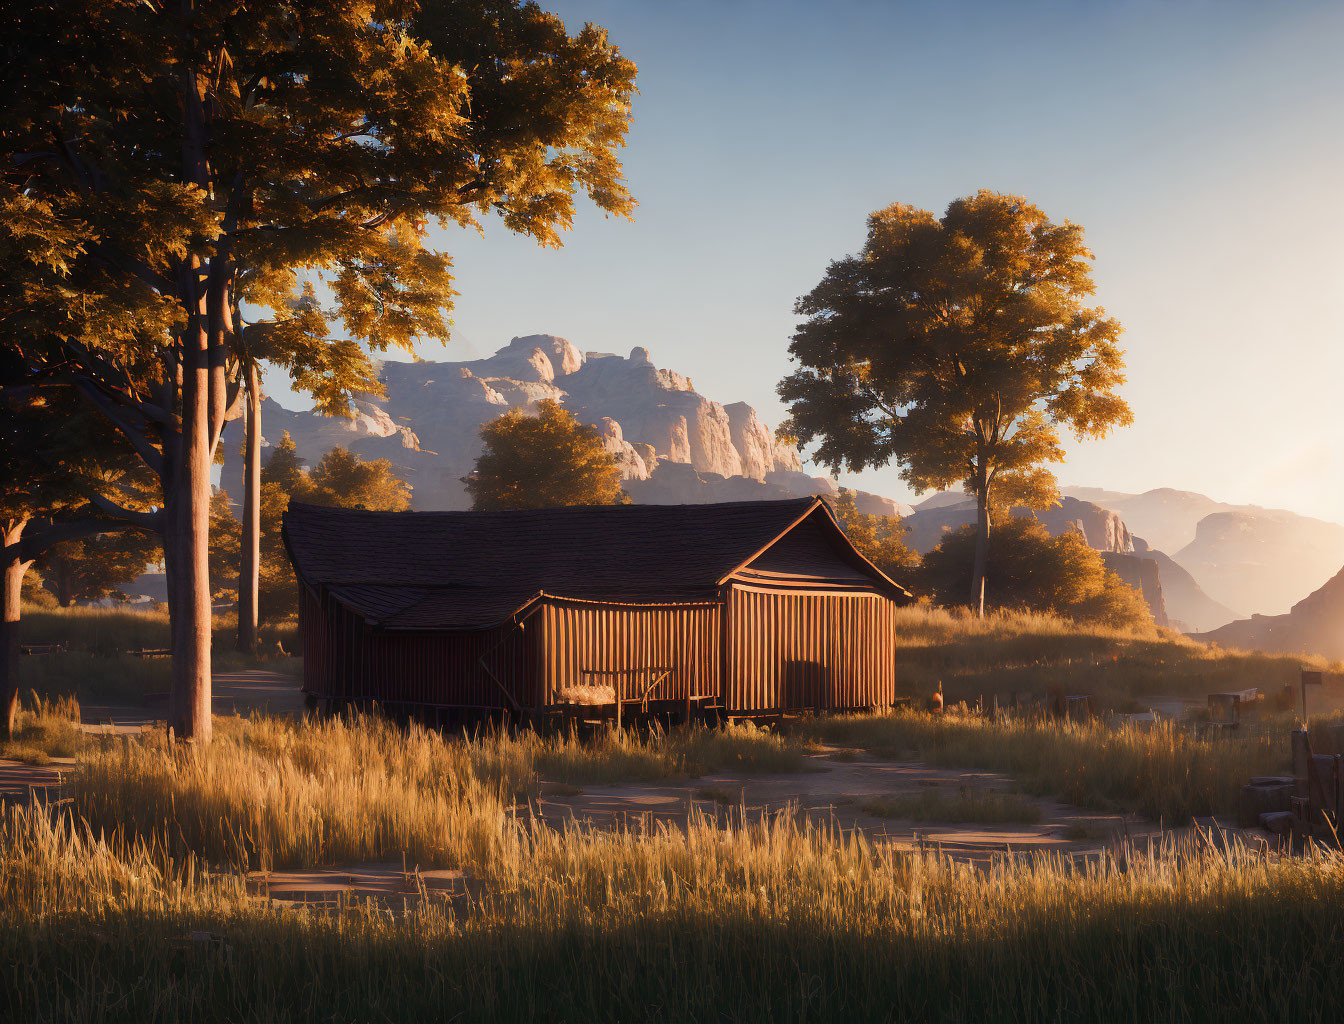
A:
284;497;905;629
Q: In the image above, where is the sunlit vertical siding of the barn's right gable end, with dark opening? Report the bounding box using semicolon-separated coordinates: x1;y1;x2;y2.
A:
723;587;896;715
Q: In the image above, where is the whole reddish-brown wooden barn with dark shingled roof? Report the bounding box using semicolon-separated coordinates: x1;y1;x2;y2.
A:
284;499;910;719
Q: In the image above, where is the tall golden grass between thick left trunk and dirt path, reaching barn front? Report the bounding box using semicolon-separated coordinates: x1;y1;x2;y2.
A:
67;715;810;868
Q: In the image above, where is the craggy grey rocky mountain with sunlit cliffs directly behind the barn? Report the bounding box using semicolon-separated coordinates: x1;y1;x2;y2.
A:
220;335;907;515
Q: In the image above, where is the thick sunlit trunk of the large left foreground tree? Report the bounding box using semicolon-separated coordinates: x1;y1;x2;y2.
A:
164;280;212;743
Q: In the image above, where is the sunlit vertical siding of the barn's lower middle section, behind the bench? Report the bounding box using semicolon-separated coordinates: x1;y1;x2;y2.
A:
538;601;722;704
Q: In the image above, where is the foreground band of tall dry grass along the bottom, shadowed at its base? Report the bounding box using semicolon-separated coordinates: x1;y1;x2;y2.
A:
0;795;1344;1021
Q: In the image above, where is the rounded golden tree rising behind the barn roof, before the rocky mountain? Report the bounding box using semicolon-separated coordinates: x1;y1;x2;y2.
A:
462;399;626;509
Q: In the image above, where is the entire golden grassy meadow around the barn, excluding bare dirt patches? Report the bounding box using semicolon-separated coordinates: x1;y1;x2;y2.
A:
0;609;1344;1021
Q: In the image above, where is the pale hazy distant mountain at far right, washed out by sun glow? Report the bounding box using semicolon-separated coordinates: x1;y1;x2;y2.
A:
1064;488;1344;614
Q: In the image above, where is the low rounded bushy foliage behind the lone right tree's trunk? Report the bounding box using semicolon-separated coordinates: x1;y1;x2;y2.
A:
921;513;1153;629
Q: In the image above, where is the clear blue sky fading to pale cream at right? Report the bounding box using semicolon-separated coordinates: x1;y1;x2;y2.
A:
275;0;1344;520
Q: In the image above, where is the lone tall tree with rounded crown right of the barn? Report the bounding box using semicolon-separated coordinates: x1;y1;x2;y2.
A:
778;191;1132;610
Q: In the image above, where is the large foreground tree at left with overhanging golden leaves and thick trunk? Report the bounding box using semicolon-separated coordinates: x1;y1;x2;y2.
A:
0;0;634;739
